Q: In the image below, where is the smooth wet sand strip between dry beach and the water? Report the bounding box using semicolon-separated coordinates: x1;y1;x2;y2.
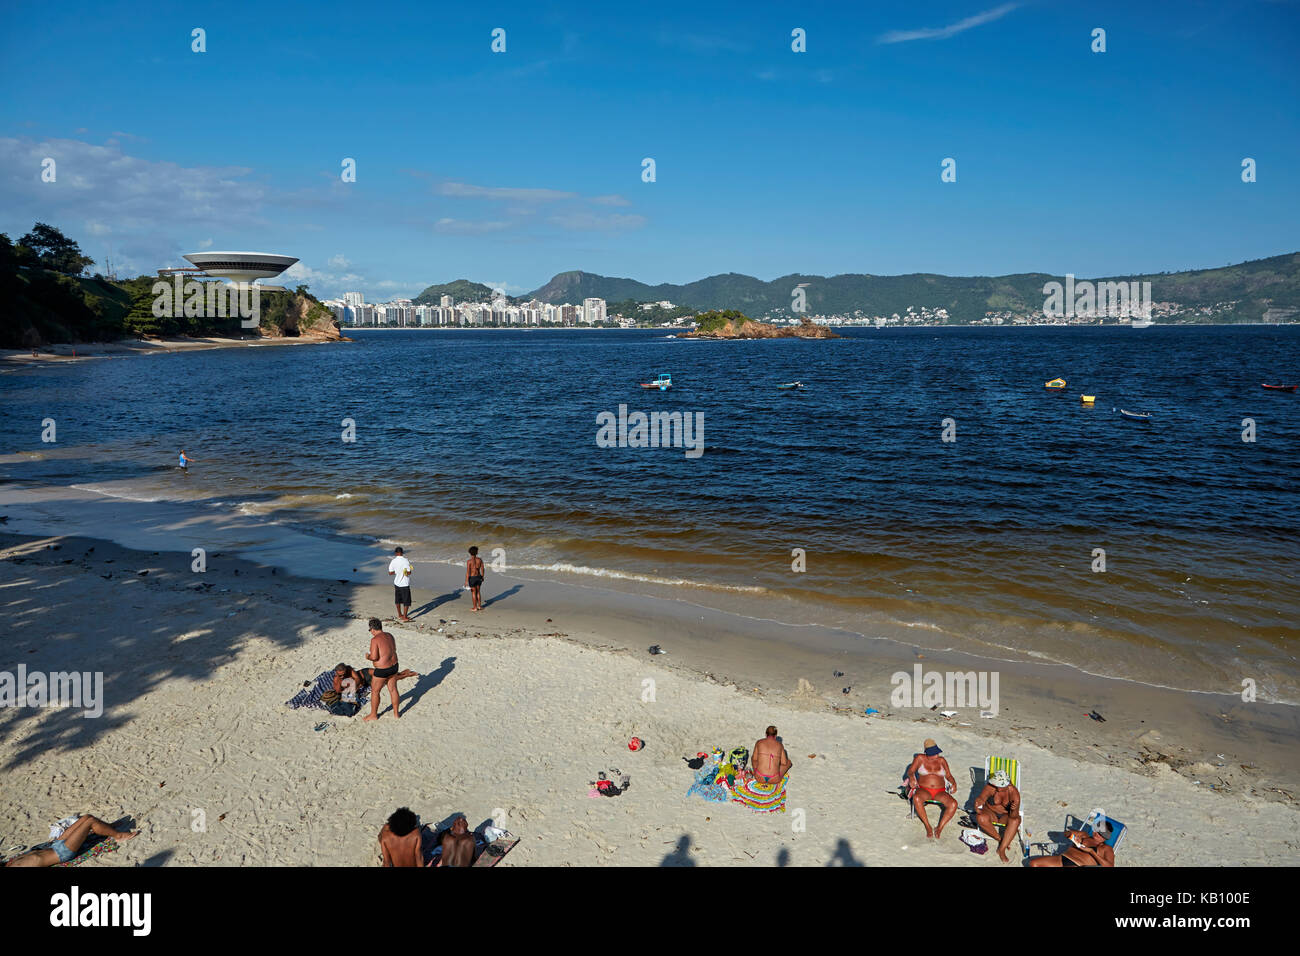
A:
0;484;1300;801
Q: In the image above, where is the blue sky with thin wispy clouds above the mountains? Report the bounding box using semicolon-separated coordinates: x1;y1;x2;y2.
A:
0;0;1300;300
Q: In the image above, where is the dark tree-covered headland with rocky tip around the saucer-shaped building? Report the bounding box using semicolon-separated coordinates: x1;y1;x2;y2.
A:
0;222;334;349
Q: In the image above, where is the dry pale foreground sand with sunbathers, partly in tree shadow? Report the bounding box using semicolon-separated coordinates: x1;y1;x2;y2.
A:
0;538;1300;868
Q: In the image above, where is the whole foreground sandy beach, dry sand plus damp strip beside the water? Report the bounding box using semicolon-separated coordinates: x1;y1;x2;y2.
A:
0;512;1300;866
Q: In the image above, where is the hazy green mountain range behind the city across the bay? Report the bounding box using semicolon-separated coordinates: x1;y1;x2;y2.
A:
419;252;1300;323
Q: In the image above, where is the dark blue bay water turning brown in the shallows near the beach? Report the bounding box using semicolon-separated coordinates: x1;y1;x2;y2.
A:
0;326;1300;704
